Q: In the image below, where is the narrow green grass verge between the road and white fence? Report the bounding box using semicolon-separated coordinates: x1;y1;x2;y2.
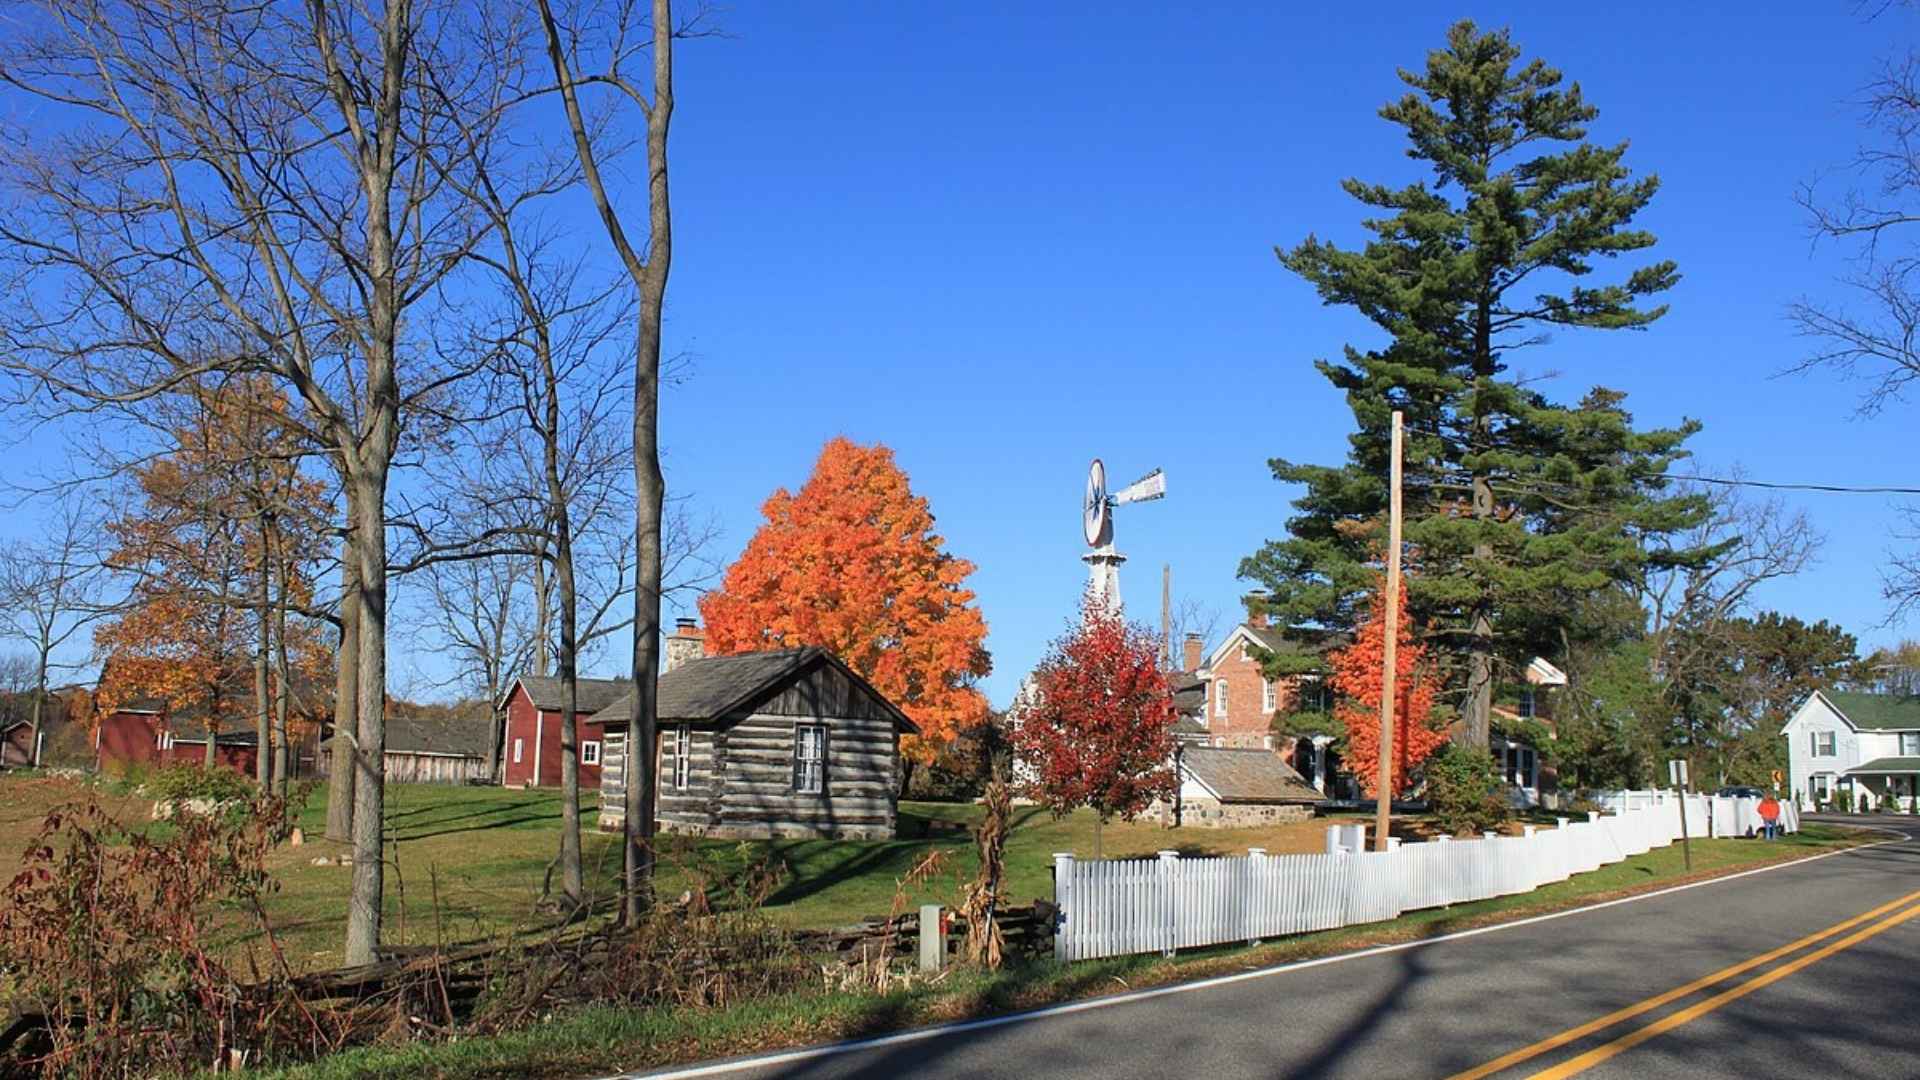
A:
240;824;1857;1080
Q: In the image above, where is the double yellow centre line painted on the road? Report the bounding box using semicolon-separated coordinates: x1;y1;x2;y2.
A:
1448;892;1920;1080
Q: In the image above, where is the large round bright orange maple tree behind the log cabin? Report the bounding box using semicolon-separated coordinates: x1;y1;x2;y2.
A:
701;436;993;763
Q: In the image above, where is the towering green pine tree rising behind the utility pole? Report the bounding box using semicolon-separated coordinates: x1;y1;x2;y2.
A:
1240;21;1705;746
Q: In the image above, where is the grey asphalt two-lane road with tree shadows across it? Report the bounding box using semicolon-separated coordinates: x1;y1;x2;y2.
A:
629;819;1920;1080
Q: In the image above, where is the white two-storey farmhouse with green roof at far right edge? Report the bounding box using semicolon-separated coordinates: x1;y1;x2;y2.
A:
1780;690;1920;809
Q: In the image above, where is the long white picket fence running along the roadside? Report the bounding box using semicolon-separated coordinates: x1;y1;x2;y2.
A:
1054;792;1799;961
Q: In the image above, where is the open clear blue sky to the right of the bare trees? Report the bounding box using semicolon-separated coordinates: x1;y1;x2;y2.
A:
15;0;1916;703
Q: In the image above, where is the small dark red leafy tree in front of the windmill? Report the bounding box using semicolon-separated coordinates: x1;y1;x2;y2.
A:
1014;600;1179;859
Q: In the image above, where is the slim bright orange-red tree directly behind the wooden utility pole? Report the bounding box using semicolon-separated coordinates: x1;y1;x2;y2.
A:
1327;582;1448;796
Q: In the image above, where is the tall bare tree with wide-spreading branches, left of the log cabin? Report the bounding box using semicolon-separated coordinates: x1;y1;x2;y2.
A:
0;0;536;963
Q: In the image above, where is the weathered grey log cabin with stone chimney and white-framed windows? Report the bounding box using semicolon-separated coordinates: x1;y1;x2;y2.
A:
588;623;918;840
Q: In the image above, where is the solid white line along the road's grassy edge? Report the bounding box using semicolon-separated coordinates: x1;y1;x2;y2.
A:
603;824;1920;1080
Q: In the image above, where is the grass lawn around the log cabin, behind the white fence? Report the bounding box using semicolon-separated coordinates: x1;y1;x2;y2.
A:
0;774;1443;970
